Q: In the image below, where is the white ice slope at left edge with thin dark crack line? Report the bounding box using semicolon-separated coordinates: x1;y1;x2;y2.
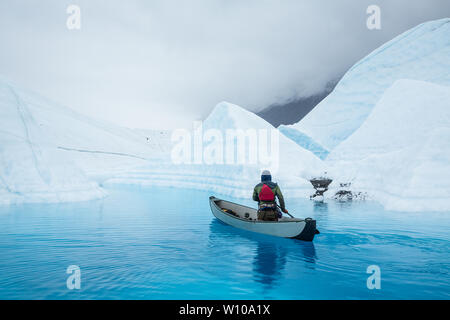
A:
0;78;165;204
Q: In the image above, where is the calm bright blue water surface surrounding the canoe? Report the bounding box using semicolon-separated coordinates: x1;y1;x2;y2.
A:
0;187;450;299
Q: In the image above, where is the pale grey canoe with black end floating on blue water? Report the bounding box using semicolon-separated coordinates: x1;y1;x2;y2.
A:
209;197;319;241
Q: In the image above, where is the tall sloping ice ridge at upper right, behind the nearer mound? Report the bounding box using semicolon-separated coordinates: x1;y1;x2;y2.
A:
279;18;450;158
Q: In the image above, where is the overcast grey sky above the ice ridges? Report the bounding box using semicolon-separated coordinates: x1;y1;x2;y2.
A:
0;0;450;129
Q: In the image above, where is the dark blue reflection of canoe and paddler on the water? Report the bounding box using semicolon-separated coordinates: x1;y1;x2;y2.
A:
210;219;316;289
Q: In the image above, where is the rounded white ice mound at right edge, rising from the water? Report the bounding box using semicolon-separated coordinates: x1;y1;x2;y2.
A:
327;80;450;211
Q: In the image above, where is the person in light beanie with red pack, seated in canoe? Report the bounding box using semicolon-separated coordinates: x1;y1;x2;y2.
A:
253;170;288;221
